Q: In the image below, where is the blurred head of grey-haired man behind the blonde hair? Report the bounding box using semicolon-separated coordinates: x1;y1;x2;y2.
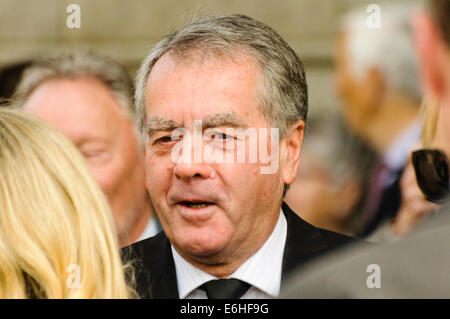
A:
16;52;146;242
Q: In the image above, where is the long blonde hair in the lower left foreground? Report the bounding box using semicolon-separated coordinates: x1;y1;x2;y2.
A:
0;109;133;298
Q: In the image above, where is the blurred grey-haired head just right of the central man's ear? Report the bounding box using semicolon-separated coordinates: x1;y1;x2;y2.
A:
286;116;375;233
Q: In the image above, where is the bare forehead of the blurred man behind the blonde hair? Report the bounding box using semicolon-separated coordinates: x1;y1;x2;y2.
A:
23;79;135;144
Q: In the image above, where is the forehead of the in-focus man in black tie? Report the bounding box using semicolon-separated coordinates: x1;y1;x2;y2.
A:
146;50;262;127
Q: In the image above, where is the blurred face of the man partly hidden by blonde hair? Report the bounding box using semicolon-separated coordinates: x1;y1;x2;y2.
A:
24;78;145;239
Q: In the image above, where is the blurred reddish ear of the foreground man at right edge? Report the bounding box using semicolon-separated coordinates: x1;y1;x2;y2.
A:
412;11;445;100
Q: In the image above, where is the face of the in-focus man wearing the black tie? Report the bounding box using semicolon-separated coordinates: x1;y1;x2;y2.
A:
146;54;290;264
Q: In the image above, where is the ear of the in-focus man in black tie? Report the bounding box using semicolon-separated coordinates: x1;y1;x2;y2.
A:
282;120;305;185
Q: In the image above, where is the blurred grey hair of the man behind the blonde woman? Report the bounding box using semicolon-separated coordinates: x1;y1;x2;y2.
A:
14;51;135;120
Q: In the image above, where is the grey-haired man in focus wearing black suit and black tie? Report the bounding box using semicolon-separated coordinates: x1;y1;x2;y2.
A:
126;15;362;298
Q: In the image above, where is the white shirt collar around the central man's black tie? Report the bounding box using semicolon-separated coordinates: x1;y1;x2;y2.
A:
172;210;287;299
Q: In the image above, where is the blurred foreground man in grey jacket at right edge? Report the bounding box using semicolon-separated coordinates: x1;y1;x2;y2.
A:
284;0;450;298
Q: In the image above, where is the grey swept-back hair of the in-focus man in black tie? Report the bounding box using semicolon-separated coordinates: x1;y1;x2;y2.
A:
135;15;308;137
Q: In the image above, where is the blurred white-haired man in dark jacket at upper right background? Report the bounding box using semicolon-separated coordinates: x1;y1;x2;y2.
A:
336;4;421;235
